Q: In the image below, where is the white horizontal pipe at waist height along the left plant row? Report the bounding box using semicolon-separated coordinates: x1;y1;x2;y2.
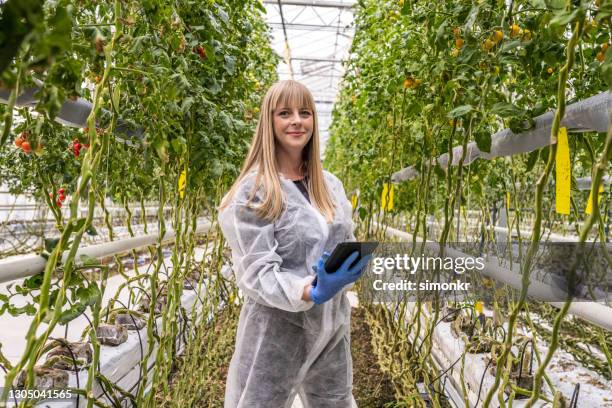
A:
0;220;211;283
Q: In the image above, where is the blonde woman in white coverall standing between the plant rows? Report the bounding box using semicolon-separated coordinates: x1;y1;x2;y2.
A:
219;81;369;408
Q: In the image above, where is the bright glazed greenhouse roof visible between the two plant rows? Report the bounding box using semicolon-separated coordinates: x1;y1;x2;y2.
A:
263;0;356;150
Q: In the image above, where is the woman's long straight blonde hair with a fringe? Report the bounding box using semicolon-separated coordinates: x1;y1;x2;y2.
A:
219;80;335;222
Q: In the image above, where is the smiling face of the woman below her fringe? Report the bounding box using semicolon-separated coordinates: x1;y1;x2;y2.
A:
274;104;314;153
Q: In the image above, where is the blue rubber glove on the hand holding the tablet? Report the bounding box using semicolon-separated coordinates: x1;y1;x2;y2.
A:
310;251;372;305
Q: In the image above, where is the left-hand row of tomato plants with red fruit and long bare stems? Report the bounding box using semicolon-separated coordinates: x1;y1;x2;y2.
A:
0;0;277;406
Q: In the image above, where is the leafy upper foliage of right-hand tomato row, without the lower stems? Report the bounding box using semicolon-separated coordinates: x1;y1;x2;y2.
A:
326;0;612;220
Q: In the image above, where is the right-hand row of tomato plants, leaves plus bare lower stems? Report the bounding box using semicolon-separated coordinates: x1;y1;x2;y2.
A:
325;0;612;406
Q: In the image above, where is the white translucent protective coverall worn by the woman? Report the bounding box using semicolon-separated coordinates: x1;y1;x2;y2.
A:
219;171;355;408
